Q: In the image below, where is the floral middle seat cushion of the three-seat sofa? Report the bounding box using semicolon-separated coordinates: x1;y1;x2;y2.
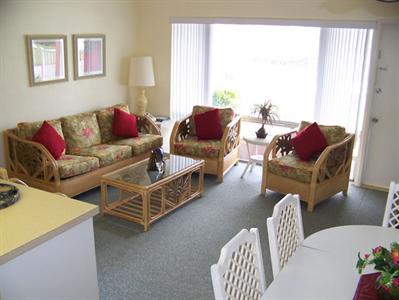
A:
74;144;132;167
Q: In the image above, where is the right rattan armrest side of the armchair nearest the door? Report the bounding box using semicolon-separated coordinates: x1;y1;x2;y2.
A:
311;134;355;183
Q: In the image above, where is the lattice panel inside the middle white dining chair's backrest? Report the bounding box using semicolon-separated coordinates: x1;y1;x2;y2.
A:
277;203;301;268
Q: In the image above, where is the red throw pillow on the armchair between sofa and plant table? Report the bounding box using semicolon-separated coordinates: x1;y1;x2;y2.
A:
194;109;223;140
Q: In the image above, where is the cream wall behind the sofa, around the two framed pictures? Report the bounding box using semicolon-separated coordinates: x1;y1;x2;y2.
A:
0;0;137;166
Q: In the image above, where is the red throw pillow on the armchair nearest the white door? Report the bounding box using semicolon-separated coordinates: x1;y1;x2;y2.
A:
290;122;328;160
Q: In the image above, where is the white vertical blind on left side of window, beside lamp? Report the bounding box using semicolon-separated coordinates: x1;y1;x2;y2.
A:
170;24;209;120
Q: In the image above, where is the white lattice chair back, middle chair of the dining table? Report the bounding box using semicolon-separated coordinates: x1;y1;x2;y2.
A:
267;194;304;278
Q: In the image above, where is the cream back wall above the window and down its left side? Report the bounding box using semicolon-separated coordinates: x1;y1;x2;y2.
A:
136;0;399;115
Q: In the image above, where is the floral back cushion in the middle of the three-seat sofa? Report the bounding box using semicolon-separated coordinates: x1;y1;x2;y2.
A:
61;113;101;155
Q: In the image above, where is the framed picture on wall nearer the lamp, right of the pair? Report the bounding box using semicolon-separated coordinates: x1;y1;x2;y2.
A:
72;34;105;80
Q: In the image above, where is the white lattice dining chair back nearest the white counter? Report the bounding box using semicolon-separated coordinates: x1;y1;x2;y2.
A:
211;228;266;300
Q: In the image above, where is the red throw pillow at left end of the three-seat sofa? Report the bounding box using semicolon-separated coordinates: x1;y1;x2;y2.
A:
32;121;66;160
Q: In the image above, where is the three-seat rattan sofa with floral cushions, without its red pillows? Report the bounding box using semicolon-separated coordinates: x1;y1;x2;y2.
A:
4;104;163;196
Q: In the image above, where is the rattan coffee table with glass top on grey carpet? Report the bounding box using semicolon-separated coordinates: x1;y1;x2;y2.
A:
101;154;205;231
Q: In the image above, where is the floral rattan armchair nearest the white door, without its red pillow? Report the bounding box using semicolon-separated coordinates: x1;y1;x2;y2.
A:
261;121;355;212
